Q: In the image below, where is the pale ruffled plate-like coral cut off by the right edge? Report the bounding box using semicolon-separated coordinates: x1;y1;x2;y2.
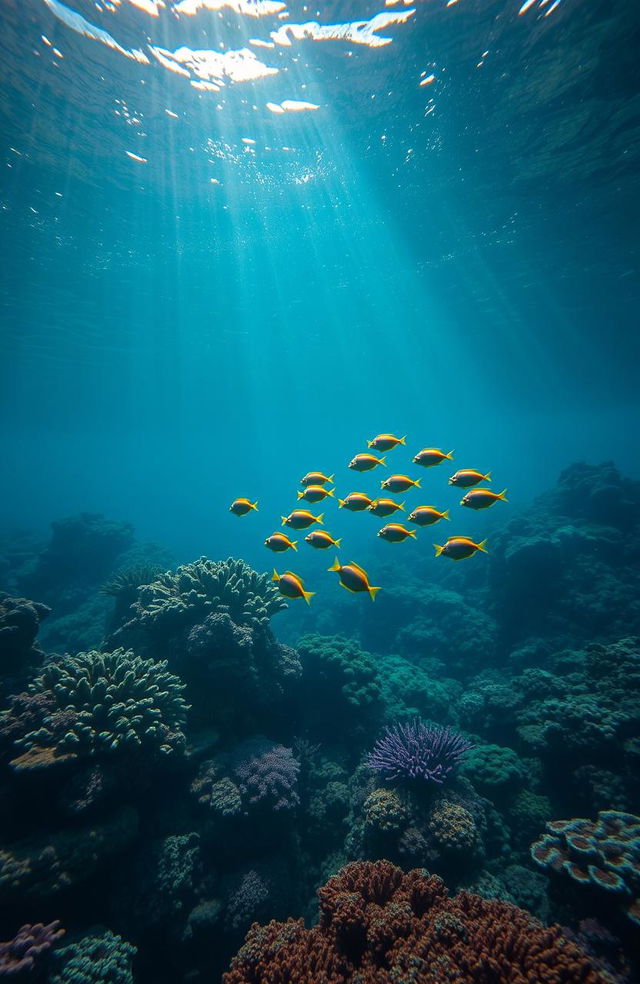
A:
531;810;640;925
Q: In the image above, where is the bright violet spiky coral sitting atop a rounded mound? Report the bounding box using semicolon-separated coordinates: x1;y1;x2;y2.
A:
366;719;473;783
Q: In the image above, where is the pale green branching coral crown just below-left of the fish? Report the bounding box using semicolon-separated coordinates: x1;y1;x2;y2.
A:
132;557;287;628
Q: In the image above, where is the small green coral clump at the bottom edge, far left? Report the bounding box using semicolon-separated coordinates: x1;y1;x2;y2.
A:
49;929;137;984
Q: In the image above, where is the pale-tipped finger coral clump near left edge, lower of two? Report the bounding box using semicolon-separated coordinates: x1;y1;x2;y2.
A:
14;649;188;768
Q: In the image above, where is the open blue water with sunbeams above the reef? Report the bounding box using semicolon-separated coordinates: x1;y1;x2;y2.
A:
0;0;640;565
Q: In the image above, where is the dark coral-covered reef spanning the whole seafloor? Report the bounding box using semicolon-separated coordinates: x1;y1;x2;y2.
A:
0;463;640;984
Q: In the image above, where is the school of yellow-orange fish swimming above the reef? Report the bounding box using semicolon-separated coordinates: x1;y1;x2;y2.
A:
229;434;508;604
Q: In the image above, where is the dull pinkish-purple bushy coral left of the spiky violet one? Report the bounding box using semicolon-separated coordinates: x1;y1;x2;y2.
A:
233;738;300;810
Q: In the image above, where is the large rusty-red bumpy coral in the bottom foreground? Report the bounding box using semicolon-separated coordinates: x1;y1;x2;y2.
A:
223;861;606;984
